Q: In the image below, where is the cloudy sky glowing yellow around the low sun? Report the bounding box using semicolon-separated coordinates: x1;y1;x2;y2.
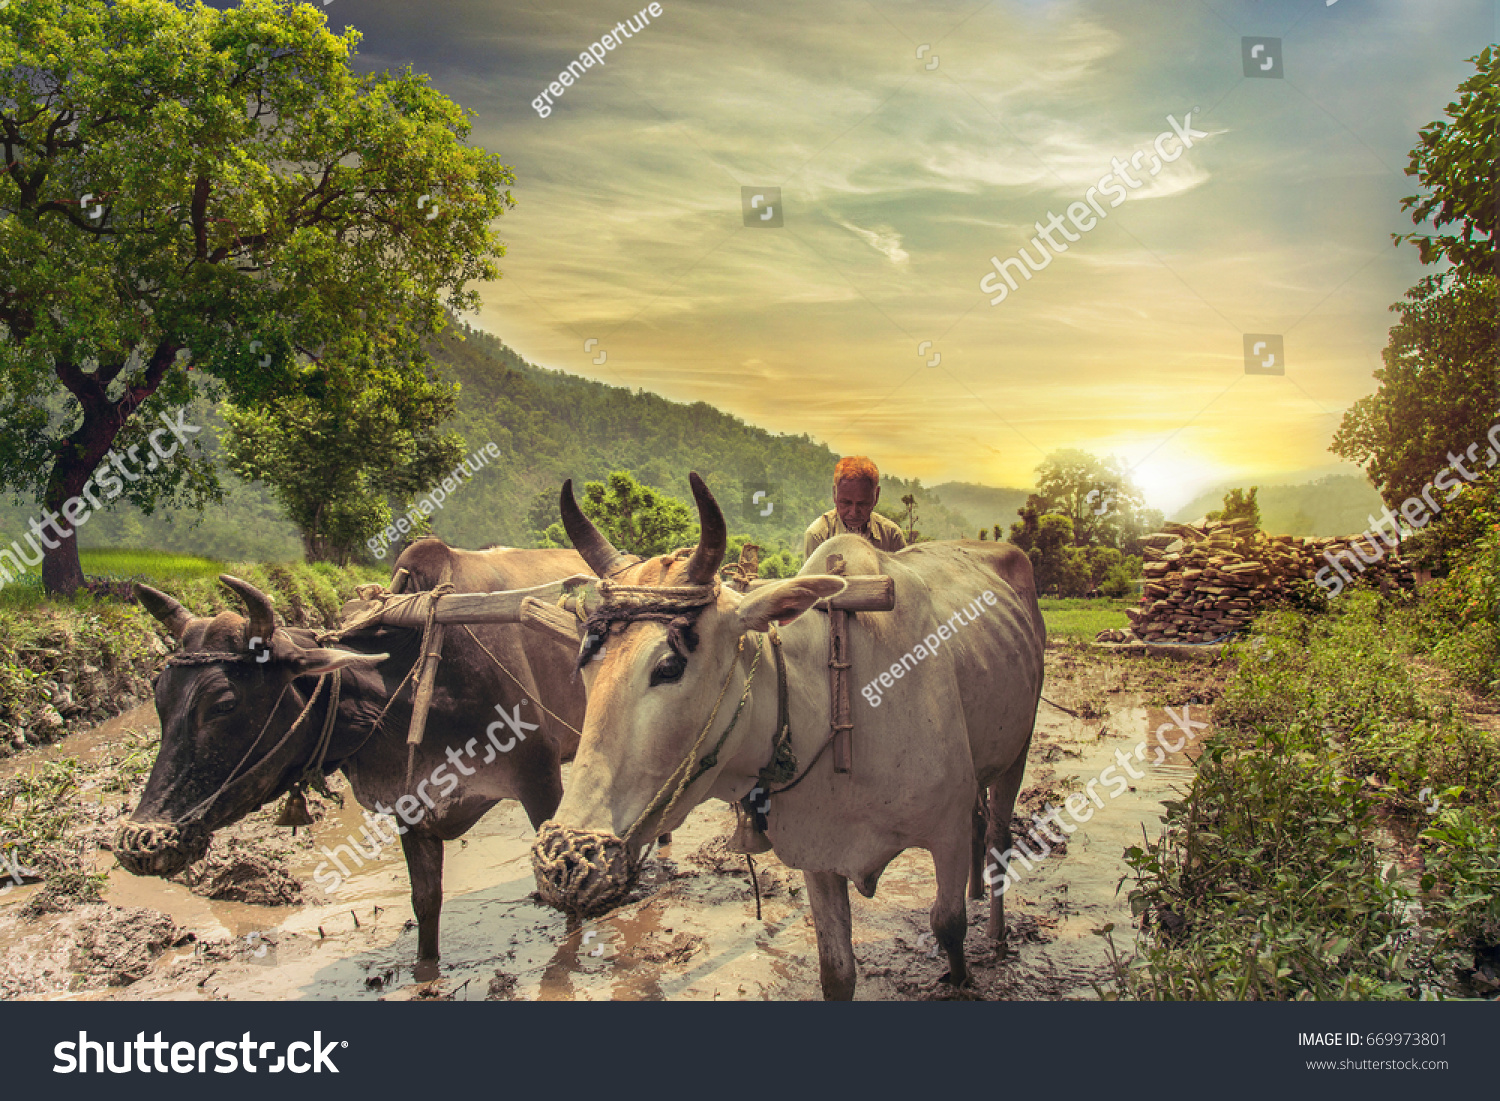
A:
246;0;1497;512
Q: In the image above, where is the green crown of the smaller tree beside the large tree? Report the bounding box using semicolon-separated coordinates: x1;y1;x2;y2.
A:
222;358;465;563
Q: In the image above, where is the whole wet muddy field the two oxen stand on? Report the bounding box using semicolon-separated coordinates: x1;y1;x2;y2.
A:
0;650;1215;1001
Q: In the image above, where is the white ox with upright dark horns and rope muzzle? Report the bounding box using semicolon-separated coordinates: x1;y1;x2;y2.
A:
533;474;1046;999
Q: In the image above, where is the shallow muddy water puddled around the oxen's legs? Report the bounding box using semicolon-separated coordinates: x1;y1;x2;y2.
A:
0;690;1196;1001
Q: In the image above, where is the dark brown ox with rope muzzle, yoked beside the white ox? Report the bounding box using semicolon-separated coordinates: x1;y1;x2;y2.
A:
116;539;587;962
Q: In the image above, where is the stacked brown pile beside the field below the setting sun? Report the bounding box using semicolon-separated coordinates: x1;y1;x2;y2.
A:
1127;519;1415;642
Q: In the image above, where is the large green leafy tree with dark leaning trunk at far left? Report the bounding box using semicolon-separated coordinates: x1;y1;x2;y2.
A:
0;0;515;593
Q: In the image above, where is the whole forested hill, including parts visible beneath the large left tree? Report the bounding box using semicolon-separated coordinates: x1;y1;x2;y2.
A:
0;326;996;560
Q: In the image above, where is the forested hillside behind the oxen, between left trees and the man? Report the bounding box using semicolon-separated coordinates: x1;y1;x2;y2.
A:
435;326;978;552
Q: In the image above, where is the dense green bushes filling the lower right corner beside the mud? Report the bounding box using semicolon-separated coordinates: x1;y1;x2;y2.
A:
1113;593;1500;999
